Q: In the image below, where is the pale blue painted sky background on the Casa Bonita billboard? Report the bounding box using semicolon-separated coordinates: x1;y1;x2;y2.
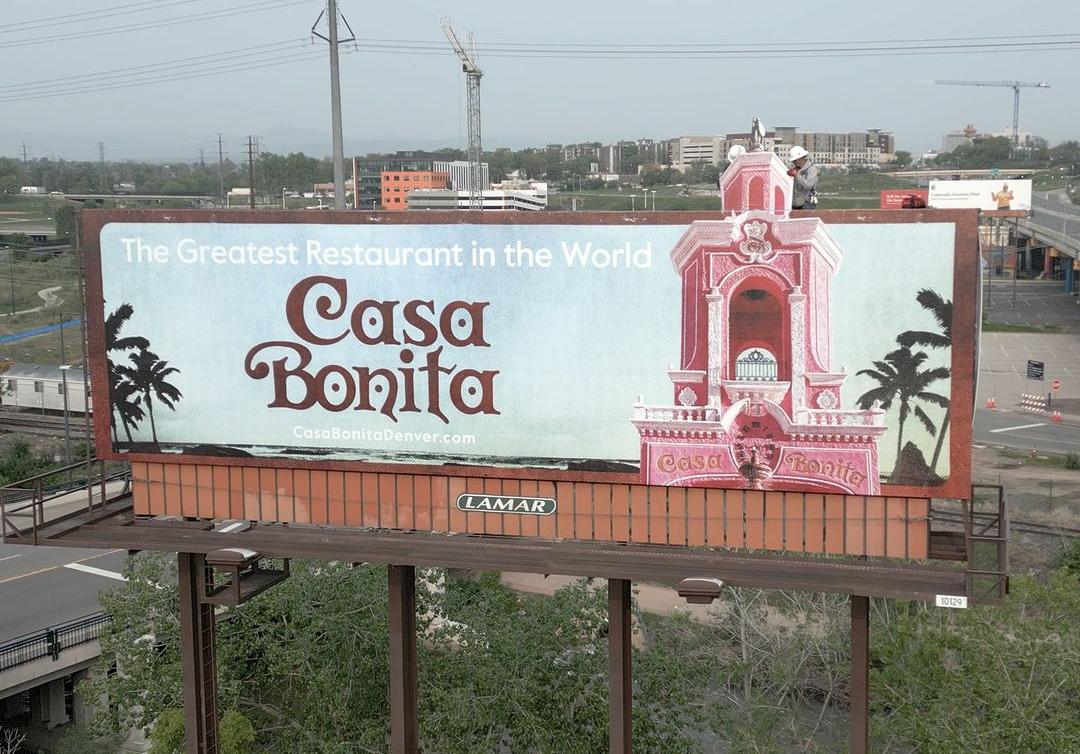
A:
102;224;953;468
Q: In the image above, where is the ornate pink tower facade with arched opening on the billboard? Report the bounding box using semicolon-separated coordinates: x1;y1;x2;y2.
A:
633;151;886;495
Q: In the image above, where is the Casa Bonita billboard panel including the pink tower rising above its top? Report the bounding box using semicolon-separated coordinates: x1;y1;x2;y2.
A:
87;152;976;497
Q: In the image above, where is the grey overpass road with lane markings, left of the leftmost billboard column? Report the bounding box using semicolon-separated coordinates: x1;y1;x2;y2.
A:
0;544;127;642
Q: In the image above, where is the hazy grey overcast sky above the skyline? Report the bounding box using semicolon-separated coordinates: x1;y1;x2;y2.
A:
0;0;1080;160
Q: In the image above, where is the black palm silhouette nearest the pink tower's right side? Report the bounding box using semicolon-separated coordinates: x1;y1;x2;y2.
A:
858;346;949;466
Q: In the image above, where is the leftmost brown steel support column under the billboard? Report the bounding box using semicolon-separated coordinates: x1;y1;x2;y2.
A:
178;552;217;754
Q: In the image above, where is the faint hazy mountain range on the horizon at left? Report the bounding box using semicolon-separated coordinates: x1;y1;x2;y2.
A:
0;125;544;162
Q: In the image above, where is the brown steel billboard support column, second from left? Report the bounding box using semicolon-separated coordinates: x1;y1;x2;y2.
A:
387;565;420;754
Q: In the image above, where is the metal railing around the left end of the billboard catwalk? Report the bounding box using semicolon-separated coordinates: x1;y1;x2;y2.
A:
0;459;131;544
